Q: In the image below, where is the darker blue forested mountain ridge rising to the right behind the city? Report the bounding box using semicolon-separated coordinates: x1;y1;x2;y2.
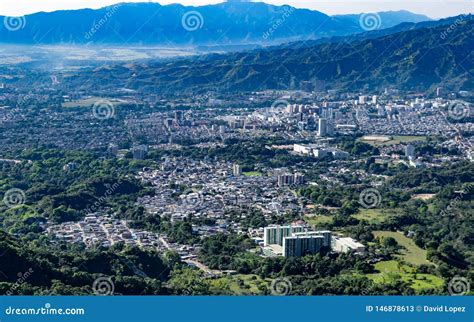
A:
64;15;474;93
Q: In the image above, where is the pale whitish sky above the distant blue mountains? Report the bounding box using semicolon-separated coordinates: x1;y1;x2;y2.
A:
0;0;474;18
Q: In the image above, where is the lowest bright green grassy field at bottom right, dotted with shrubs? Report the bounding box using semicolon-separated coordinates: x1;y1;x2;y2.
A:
367;260;444;291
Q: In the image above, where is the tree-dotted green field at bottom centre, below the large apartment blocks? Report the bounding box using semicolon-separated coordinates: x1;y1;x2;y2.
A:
210;274;271;295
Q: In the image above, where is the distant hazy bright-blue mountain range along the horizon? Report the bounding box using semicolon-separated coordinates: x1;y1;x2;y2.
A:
0;1;430;46
